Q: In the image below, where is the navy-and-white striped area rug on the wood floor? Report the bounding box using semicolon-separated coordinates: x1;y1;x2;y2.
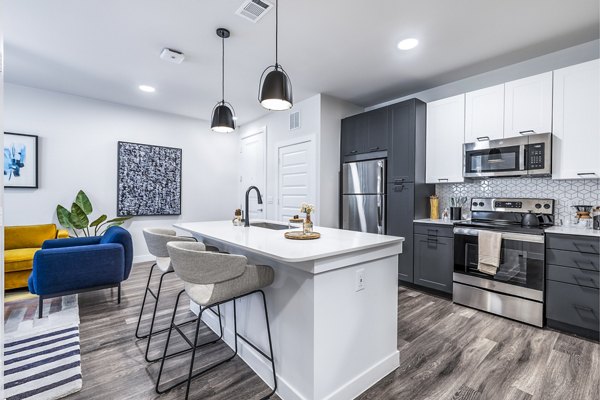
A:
4;298;82;400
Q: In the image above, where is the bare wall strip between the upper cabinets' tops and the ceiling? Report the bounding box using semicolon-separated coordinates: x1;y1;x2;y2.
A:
365;40;600;111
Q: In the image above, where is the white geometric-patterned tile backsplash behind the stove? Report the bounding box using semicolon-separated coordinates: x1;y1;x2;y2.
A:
435;178;600;224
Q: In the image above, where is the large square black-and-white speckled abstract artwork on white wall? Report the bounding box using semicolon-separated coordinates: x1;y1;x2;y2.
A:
117;142;182;217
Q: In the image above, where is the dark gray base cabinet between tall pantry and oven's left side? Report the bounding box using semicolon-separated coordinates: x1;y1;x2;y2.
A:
414;225;454;294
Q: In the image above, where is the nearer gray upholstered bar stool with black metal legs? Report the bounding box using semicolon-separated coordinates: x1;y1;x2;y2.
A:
155;242;277;399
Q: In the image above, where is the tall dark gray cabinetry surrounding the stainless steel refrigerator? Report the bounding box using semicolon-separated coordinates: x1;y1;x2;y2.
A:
340;99;435;283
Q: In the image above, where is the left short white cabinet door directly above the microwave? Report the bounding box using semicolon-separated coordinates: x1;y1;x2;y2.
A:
465;84;504;143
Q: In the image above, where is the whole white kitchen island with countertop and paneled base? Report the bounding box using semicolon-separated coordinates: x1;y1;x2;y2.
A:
175;221;404;400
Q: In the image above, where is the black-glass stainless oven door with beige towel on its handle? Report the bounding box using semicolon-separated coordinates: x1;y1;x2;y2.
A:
454;228;544;302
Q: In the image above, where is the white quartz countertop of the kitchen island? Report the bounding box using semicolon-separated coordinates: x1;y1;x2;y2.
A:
174;221;404;263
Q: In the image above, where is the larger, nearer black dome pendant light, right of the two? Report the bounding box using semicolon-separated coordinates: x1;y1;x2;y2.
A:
258;0;294;111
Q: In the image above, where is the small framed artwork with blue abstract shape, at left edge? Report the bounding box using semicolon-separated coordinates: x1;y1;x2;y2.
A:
4;132;38;189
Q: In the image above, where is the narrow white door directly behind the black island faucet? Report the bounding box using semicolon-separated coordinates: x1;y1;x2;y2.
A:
239;131;267;221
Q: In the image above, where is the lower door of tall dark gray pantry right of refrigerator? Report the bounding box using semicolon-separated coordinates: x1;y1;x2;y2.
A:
387;183;415;282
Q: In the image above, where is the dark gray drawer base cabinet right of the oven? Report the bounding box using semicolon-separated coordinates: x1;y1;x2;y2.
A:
546;234;600;340
